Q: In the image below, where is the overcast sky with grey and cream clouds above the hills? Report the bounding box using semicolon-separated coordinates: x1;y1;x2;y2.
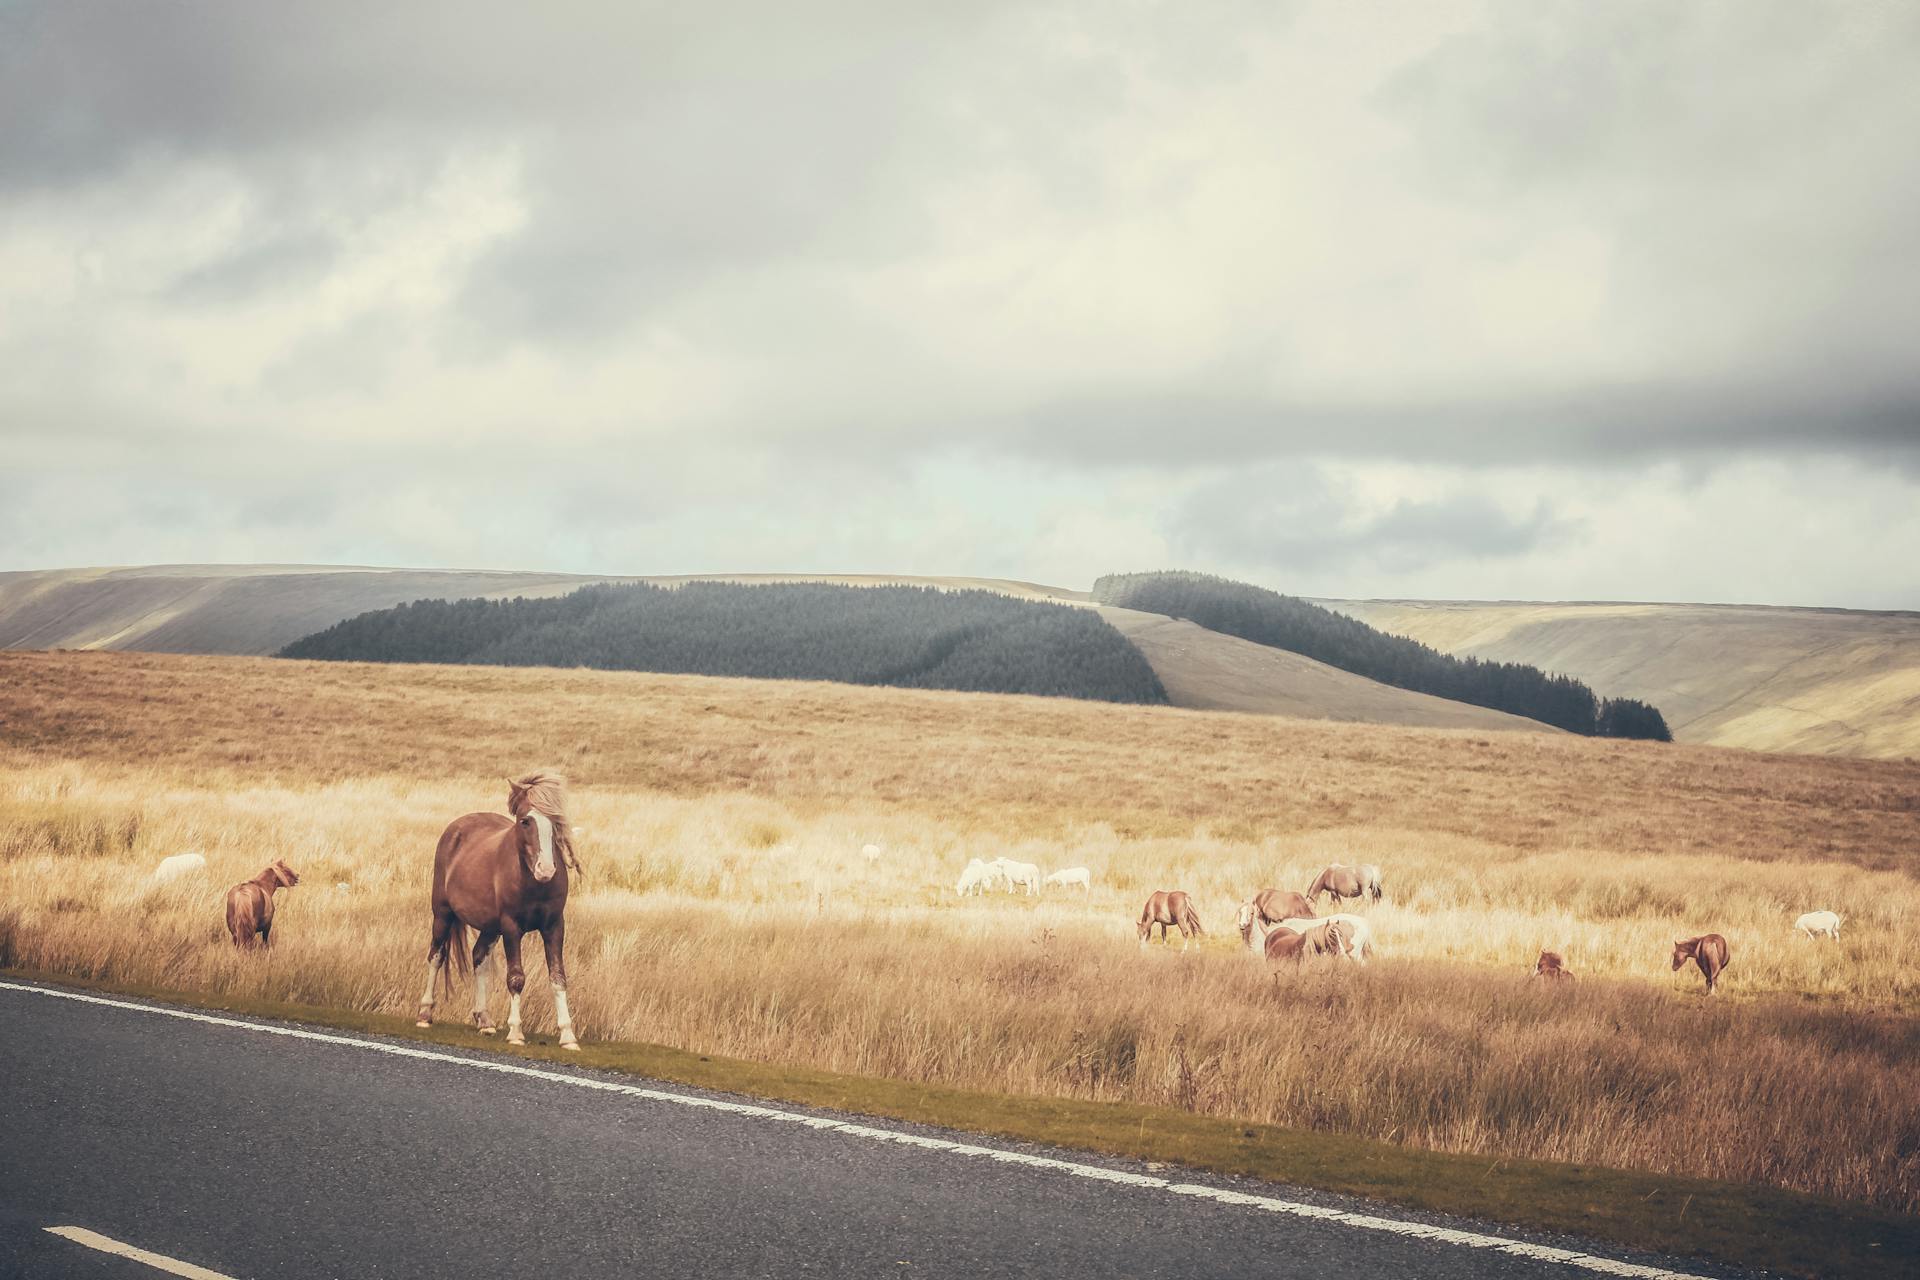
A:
0;0;1920;608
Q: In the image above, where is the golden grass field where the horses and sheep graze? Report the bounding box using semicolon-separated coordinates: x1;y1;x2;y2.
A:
0;652;1920;1213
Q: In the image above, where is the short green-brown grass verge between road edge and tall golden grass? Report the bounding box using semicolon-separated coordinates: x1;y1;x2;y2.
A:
11;967;1920;1278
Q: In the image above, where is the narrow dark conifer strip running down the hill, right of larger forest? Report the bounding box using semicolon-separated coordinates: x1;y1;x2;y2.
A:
1092;572;1672;743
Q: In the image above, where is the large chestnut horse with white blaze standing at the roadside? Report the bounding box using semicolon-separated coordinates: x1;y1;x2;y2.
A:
419;773;580;1050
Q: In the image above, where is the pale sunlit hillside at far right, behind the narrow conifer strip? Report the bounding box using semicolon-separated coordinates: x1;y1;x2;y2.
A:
1321;601;1920;758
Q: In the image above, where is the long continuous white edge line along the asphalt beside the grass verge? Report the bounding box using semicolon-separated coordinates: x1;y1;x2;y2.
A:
0;981;1707;1280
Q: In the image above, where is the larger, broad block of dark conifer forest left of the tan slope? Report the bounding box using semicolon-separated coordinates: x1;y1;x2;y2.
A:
280;581;1167;702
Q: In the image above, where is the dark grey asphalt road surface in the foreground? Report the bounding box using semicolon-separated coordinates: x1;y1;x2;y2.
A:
0;988;1728;1280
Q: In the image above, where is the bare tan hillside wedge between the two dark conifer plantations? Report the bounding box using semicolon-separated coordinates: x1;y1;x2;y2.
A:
1098;604;1559;733
